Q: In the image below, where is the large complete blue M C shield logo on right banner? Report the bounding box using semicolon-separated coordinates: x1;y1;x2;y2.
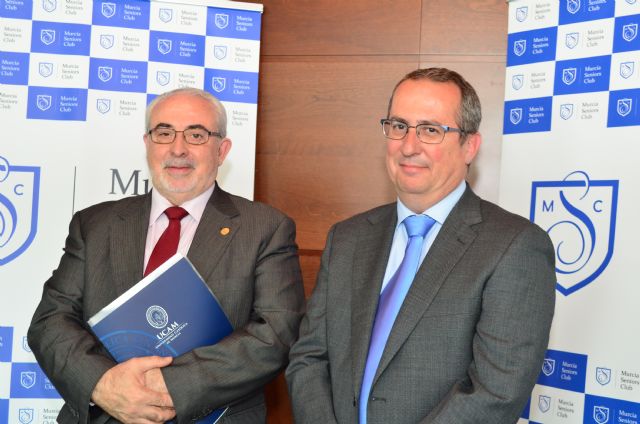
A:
530;171;618;296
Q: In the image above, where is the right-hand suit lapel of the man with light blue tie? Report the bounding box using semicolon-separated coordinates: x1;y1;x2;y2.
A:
373;187;482;384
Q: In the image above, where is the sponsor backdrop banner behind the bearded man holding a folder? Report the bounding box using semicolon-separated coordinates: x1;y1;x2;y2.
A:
0;0;262;424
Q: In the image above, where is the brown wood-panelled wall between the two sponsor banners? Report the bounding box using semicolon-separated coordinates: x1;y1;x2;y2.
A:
249;0;507;423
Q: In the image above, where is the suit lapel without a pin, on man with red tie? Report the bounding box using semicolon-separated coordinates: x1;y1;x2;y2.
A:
109;193;151;296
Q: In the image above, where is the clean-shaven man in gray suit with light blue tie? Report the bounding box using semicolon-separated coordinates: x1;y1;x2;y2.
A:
286;68;555;424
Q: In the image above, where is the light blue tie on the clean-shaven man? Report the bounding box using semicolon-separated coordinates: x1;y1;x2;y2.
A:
359;215;435;424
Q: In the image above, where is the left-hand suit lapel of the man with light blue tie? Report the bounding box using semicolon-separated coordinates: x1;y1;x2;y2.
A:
351;203;397;397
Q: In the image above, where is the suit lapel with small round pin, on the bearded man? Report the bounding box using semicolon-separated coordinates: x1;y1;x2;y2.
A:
187;184;240;281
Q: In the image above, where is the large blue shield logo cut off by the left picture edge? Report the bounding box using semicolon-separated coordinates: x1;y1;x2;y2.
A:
0;156;40;265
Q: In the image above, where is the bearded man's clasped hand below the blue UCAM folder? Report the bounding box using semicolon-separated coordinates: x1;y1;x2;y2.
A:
91;356;176;424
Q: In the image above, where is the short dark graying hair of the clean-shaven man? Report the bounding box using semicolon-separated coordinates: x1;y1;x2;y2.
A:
387;68;482;137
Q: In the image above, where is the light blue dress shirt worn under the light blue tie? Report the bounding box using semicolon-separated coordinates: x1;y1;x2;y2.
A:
380;180;466;292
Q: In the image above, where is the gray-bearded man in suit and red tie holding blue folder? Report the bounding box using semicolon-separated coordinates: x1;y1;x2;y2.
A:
28;88;304;424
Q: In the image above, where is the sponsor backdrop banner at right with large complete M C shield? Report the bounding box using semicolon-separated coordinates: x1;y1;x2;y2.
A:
500;0;640;424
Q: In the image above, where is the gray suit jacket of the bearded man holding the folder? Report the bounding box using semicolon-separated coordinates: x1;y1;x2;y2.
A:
28;187;304;424
